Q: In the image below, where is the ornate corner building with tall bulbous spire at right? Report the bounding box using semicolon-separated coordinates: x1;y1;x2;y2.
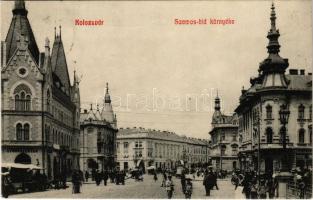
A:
235;5;312;173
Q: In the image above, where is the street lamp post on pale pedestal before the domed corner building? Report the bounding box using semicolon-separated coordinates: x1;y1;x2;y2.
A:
276;104;291;199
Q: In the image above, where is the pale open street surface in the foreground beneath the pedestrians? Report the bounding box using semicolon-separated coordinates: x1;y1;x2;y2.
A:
9;175;243;199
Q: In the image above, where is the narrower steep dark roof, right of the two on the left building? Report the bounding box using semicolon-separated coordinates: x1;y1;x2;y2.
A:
51;34;70;93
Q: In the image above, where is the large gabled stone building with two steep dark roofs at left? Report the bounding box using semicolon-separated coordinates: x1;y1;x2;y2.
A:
1;1;80;178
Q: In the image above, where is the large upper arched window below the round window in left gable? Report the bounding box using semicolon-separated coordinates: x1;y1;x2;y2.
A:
14;84;32;111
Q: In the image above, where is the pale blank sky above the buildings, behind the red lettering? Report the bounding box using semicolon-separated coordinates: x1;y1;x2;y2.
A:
1;0;312;138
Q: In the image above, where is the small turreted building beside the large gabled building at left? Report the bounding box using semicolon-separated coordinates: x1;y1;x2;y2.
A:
80;84;118;171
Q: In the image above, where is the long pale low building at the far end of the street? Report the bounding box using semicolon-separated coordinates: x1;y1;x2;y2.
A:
116;127;208;169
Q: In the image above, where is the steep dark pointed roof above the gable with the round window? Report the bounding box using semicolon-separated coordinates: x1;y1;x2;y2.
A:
5;1;39;64
